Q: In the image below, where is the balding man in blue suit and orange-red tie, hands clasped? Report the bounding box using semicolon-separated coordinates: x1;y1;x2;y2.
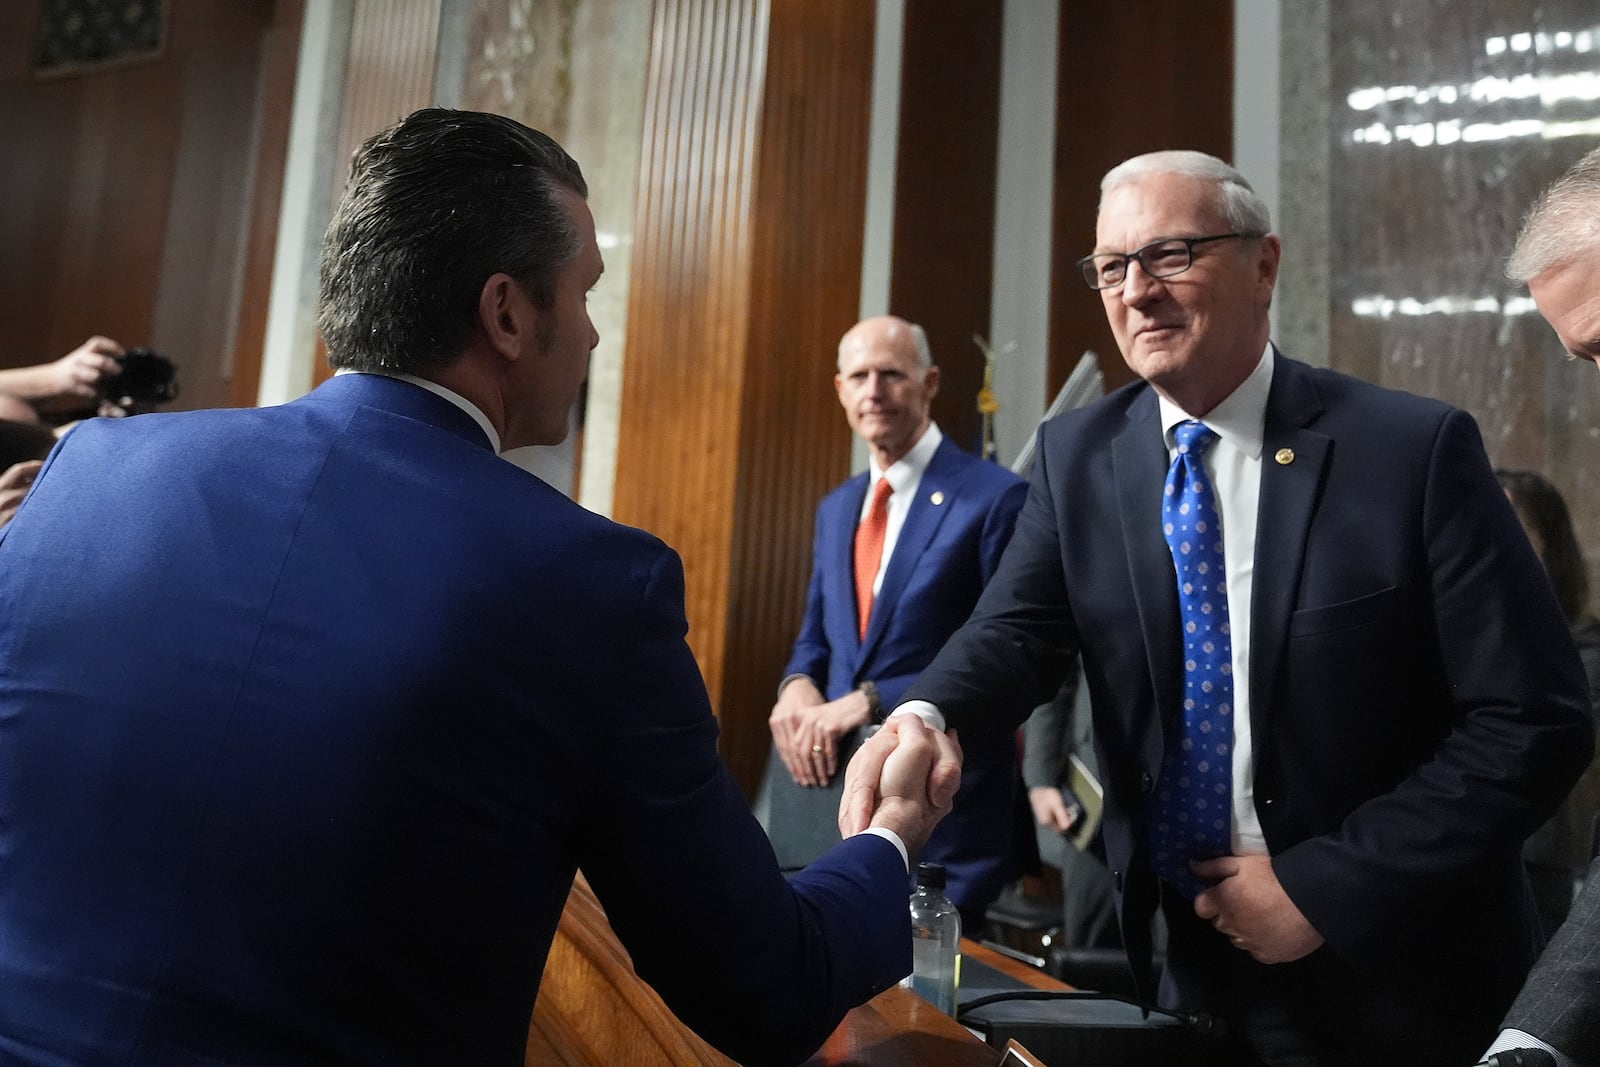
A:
763;315;1027;933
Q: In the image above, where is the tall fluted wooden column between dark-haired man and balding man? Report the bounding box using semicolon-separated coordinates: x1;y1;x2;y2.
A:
613;0;874;792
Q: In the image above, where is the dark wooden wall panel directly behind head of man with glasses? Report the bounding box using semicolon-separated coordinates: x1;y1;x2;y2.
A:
1050;0;1234;395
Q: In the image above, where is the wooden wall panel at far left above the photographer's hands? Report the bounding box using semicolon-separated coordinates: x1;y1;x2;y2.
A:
0;0;284;408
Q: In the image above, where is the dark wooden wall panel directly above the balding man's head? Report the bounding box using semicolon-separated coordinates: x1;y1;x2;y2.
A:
890;0;1005;453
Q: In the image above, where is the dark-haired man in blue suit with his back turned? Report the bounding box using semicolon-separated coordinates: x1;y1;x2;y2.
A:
0;110;960;1067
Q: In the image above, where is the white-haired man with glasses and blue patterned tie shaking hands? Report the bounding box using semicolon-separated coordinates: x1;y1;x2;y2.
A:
842;152;1594;1067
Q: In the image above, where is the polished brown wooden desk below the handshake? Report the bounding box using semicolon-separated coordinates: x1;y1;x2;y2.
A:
523;877;1067;1067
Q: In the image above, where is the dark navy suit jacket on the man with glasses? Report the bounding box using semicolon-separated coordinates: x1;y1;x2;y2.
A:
907;357;1592;1062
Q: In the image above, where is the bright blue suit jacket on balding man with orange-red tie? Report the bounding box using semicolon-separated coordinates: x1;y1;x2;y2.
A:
766;437;1027;907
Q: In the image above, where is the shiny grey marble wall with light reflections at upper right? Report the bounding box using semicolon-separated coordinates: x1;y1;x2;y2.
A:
1277;0;1600;585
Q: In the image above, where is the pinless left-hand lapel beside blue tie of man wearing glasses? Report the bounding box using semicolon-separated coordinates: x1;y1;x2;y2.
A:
1112;389;1184;735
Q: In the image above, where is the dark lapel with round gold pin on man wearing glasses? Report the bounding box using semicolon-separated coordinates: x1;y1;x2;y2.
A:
1250;355;1333;752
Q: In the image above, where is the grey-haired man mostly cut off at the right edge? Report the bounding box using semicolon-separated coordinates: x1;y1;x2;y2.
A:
1490;149;1600;1067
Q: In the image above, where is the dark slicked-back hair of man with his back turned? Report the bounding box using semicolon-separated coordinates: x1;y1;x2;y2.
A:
318;107;589;374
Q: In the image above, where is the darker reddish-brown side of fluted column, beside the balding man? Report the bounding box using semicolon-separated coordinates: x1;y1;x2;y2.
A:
723;0;874;796
